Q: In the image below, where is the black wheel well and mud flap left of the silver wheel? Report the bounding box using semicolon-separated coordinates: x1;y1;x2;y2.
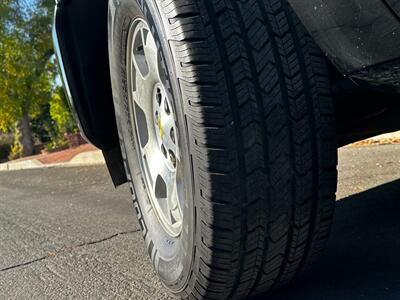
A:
56;0;126;185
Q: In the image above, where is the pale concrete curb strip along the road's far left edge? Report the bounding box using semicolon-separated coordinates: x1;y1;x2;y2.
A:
0;151;105;172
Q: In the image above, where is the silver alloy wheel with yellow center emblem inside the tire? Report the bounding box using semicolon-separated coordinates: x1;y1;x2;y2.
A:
127;19;183;237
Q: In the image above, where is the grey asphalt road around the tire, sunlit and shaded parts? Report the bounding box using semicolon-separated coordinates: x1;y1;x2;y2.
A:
0;145;400;300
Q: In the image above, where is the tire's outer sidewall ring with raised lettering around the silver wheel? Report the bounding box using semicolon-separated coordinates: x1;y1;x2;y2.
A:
108;0;195;293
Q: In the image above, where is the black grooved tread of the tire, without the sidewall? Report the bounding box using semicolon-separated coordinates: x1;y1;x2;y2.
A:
160;0;337;299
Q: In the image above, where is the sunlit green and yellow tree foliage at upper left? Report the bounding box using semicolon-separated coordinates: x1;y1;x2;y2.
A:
0;0;74;157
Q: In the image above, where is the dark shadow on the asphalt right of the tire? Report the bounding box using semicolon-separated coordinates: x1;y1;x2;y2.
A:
258;180;400;300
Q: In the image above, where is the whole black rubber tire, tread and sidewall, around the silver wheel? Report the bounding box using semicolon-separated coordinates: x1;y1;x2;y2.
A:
109;0;337;299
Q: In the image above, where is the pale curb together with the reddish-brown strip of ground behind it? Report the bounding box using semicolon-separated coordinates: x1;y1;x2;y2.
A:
0;144;105;172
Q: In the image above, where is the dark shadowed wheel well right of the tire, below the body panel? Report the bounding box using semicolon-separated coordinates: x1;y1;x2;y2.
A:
330;65;400;146
